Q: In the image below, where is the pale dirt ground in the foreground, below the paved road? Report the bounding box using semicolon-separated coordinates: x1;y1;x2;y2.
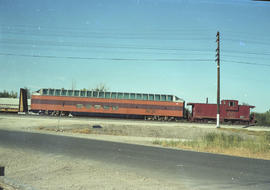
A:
0;146;185;190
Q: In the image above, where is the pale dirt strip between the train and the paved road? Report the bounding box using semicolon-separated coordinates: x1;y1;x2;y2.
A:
0;115;270;145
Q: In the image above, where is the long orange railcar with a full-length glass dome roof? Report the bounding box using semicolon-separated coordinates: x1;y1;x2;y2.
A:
31;88;185;120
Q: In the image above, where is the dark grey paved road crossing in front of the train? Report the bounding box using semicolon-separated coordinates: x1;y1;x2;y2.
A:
0;130;270;190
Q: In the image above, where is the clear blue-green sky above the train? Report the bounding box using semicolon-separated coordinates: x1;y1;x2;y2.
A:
0;0;270;112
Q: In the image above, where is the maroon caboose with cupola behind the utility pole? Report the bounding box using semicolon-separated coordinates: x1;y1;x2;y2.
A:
187;100;255;124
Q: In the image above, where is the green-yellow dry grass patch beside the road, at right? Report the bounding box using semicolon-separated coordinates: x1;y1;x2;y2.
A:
153;132;270;160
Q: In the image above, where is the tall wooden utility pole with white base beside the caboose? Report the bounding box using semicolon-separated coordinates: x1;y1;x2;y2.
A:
216;31;220;128
